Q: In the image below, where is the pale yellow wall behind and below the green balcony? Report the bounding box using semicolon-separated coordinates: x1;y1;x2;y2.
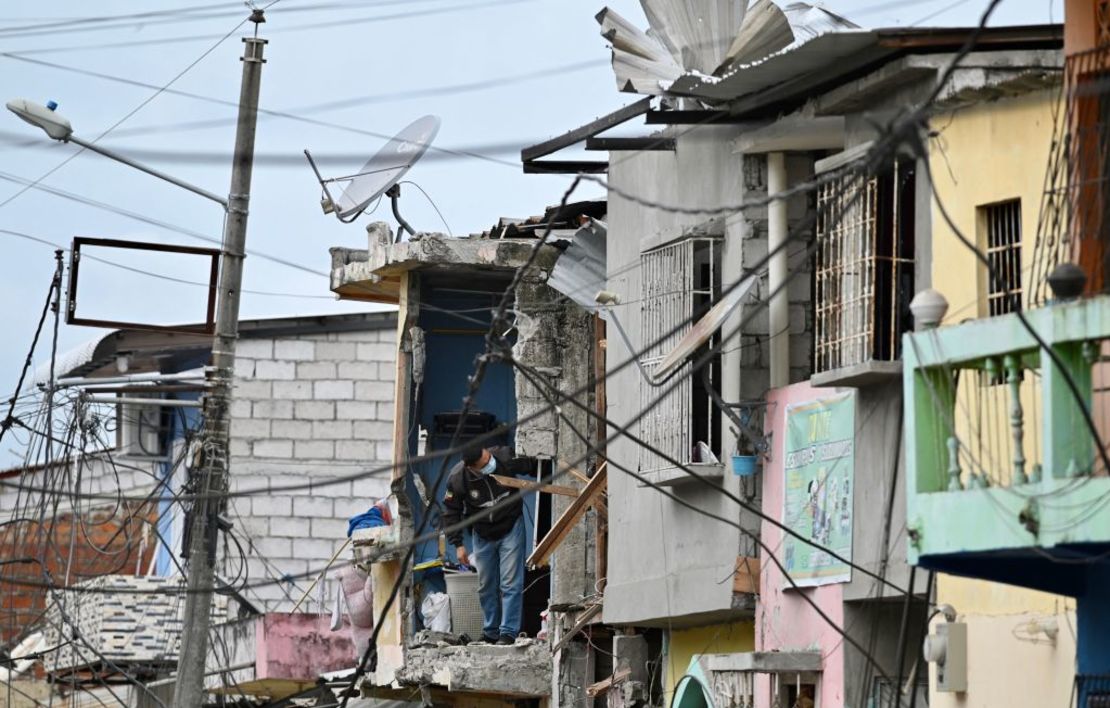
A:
929;90;1076;708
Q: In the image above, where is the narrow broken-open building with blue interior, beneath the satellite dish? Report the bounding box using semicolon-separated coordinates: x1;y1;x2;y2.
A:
332;202;605;705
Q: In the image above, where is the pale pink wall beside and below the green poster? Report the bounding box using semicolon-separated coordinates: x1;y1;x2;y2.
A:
756;383;845;708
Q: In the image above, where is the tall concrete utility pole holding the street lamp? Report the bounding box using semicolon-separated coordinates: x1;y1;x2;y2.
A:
173;16;266;708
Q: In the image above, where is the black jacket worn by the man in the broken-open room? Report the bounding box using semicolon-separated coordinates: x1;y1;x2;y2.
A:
443;447;528;547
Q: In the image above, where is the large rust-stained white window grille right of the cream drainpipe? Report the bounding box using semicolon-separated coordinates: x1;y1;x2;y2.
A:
814;161;915;372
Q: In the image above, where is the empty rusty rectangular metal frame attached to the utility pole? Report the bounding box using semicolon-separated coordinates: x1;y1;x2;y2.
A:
65;236;221;334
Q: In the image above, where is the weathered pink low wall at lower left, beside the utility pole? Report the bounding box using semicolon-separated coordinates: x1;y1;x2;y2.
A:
254;613;356;681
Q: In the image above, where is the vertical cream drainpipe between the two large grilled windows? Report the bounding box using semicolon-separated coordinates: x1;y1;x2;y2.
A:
767;152;790;388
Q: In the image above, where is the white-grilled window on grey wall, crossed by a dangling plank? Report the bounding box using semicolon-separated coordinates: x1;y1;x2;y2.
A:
639;236;722;472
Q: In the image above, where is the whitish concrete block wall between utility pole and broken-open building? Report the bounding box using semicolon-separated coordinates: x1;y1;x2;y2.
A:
224;320;396;611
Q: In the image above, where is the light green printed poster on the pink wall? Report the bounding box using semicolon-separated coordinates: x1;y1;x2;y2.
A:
780;393;856;587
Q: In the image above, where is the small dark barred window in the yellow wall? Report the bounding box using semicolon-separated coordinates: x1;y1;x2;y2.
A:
979;199;1021;317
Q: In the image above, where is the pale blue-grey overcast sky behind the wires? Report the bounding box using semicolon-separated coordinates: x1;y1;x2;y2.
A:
0;0;1062;466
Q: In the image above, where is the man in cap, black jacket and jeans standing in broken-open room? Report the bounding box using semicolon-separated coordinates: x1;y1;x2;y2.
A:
443;445;525;645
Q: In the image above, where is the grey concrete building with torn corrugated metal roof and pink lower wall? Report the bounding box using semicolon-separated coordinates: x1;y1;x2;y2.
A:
522;3;1074;708
